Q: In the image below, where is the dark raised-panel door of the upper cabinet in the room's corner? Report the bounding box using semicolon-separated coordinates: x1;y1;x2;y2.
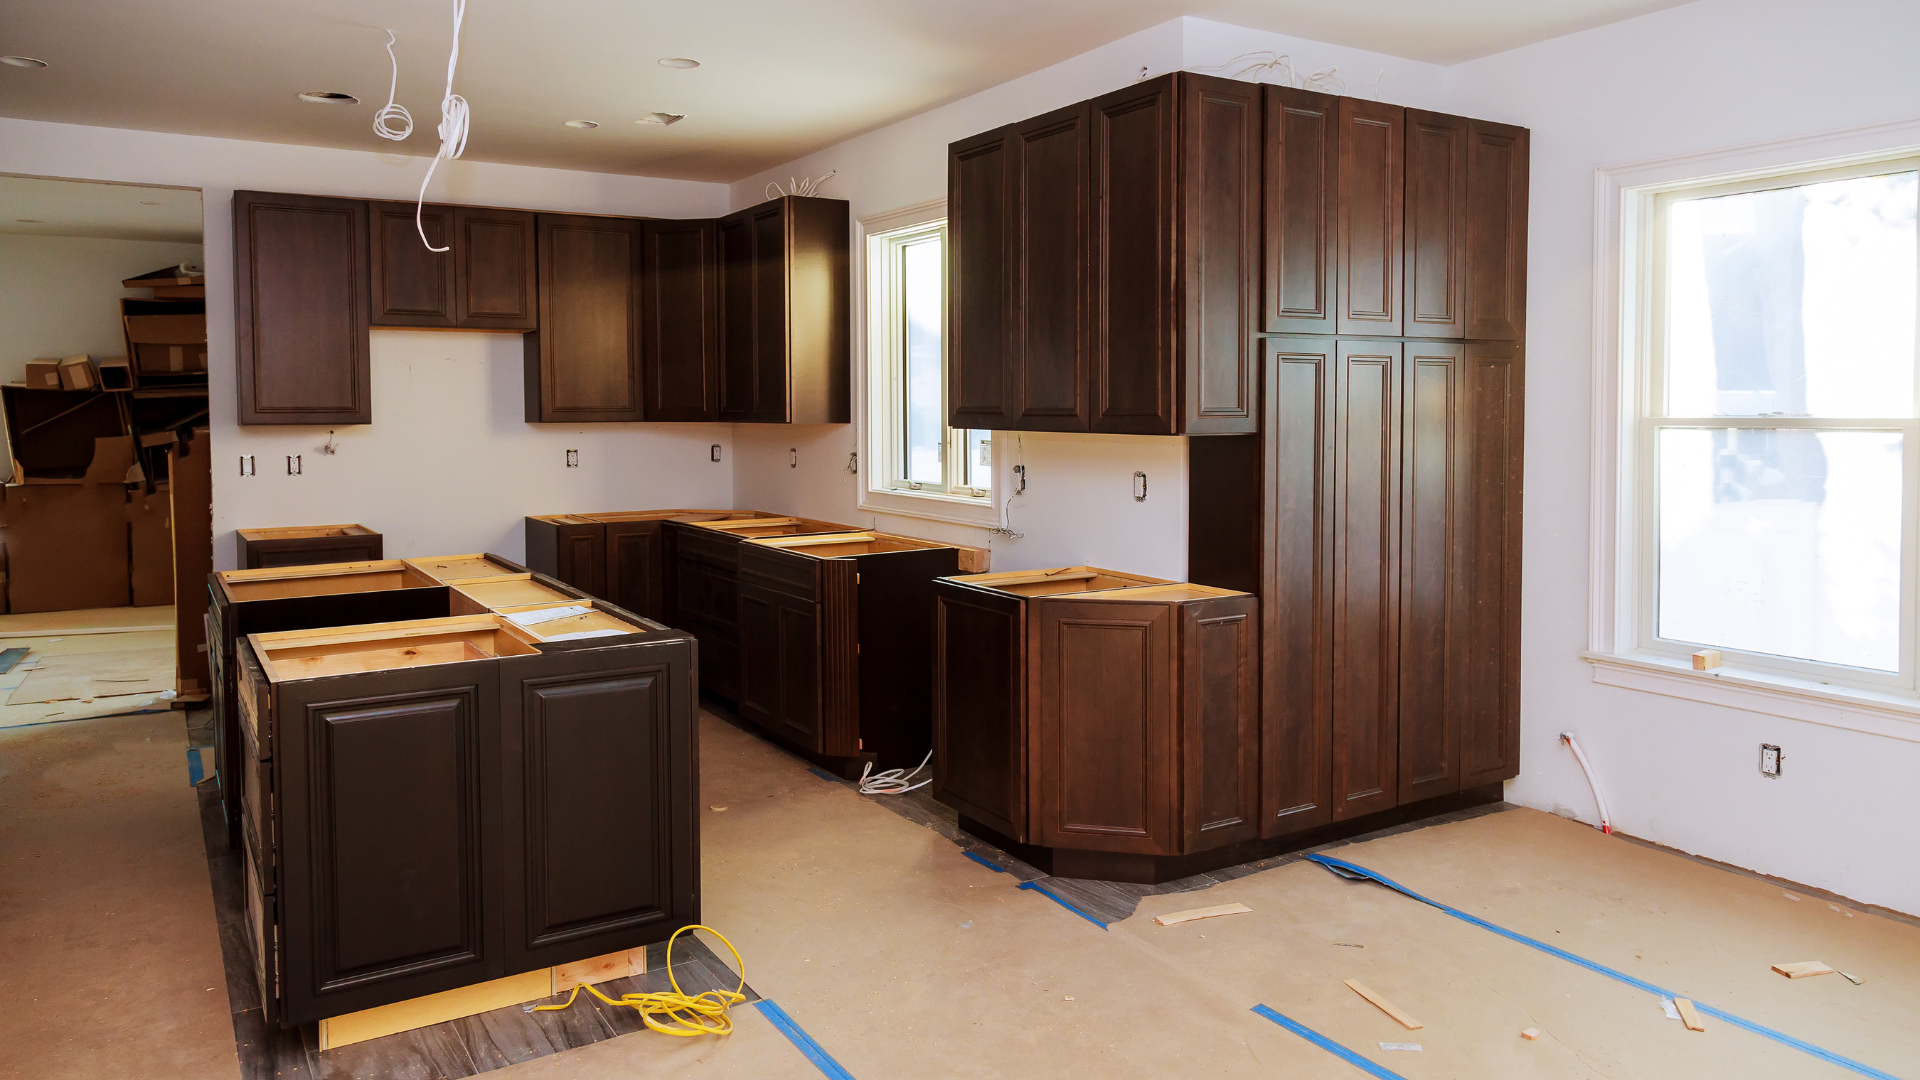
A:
639;219;720;421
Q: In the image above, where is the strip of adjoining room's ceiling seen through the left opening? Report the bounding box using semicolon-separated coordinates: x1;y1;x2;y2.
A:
0;173;202;244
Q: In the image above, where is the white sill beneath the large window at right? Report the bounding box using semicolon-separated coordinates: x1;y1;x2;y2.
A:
1580;651;1920;742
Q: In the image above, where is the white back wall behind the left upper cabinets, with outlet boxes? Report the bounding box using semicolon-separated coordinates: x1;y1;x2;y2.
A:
0;115;732;567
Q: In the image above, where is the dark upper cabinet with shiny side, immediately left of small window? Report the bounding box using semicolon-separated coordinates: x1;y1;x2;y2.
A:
718;196;852;423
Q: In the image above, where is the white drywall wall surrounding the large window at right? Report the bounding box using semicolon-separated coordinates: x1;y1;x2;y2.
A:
1452;0;1920;913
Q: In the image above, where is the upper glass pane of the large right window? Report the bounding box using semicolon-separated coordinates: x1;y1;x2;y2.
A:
1665;171;1920;417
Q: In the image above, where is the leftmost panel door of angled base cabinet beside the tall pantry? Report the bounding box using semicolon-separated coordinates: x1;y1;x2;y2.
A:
933;580;1027;842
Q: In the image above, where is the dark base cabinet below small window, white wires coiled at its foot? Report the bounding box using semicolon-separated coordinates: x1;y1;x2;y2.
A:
737;532;960;769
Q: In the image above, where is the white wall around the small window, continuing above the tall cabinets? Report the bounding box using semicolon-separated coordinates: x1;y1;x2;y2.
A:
733;17;1448;577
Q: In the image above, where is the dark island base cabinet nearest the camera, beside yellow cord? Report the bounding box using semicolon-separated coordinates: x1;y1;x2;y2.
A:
240;601;699;1026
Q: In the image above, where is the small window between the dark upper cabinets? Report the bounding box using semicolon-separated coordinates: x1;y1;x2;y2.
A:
862;204;993;523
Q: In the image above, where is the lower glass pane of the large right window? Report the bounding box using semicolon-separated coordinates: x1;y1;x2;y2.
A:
1657;426;1910;671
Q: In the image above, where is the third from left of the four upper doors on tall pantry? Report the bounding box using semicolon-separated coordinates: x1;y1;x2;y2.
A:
1404;110;1467;338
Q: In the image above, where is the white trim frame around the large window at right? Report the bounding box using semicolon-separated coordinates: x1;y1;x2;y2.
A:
1582;119;1920;742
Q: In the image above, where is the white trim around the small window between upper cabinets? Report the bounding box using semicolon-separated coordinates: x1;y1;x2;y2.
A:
849;198;1004;528
